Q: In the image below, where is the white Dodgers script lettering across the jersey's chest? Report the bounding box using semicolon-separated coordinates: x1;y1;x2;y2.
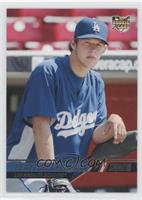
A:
55;110;97;138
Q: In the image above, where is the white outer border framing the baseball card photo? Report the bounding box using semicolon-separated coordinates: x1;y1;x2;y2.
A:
0;0;142;200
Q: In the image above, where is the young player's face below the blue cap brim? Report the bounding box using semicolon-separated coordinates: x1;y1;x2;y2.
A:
75;39;107;69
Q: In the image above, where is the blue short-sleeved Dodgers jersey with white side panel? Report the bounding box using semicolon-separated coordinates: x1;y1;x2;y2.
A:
7;56;107;160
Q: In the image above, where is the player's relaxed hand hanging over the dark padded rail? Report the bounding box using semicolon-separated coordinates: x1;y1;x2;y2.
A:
105;114;127;144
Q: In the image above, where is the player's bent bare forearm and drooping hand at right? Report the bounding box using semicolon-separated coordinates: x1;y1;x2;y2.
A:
93;114;127;144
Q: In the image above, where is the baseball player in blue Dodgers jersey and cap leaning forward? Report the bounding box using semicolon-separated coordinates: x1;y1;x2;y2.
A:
7;17;136;192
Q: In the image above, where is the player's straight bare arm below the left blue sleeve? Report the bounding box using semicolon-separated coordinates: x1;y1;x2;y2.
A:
32;116;54;160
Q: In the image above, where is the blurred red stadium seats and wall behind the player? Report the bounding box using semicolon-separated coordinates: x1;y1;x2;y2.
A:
7;8;137;136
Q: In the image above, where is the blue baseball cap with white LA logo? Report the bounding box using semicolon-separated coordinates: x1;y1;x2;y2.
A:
74;17;108;44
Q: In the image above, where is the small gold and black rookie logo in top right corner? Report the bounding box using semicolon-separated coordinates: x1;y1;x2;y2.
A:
112;16;130;32
